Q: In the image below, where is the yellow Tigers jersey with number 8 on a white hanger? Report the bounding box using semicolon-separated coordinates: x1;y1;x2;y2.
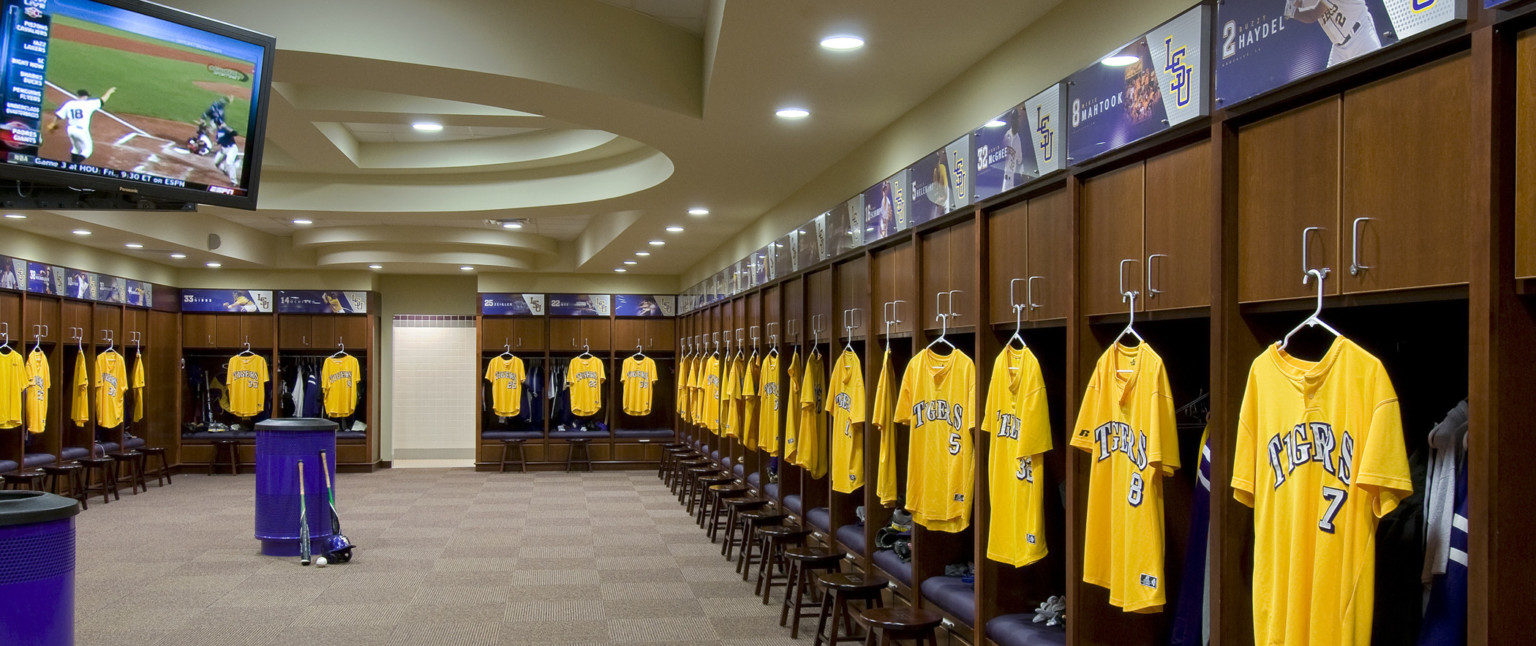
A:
1072;342;1178;612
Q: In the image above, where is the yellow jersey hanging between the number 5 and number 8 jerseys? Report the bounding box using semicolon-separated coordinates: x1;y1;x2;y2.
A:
982;345;1051;568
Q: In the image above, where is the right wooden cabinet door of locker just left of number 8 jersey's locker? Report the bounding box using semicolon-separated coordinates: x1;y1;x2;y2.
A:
1023;189;1072;321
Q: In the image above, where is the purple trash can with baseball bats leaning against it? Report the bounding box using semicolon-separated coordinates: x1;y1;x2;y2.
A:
257;417;338;557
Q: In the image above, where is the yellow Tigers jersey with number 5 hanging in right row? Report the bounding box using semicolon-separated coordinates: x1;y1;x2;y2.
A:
895;350;975;532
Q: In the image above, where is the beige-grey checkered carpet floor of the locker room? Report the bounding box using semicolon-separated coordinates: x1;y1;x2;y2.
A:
77;470;816;646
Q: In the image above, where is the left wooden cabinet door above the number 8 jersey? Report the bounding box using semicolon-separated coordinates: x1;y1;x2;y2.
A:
1078;163;1146;315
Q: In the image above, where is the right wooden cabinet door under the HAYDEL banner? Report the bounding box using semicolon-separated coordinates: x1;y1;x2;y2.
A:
1329;52;1487;292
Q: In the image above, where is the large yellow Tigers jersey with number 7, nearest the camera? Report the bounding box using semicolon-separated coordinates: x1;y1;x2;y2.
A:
1232;336;1413;644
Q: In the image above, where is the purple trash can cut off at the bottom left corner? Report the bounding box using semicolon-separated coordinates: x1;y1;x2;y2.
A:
0;491;80;646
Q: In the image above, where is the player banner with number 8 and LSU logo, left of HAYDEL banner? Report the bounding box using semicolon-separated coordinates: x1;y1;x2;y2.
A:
1069;5;1210;164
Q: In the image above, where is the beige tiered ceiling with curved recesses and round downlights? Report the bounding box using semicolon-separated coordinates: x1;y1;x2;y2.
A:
0;0;1058;276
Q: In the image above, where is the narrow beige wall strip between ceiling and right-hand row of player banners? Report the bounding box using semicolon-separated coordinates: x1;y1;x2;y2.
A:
679;0;1195;283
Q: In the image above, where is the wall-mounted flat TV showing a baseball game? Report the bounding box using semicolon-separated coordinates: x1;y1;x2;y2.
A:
0;0;272;207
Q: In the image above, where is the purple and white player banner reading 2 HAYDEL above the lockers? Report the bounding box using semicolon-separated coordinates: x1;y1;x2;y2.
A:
1215;0;1456;107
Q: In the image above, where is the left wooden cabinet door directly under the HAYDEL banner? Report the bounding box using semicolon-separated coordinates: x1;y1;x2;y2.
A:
1238;98;1339;302
